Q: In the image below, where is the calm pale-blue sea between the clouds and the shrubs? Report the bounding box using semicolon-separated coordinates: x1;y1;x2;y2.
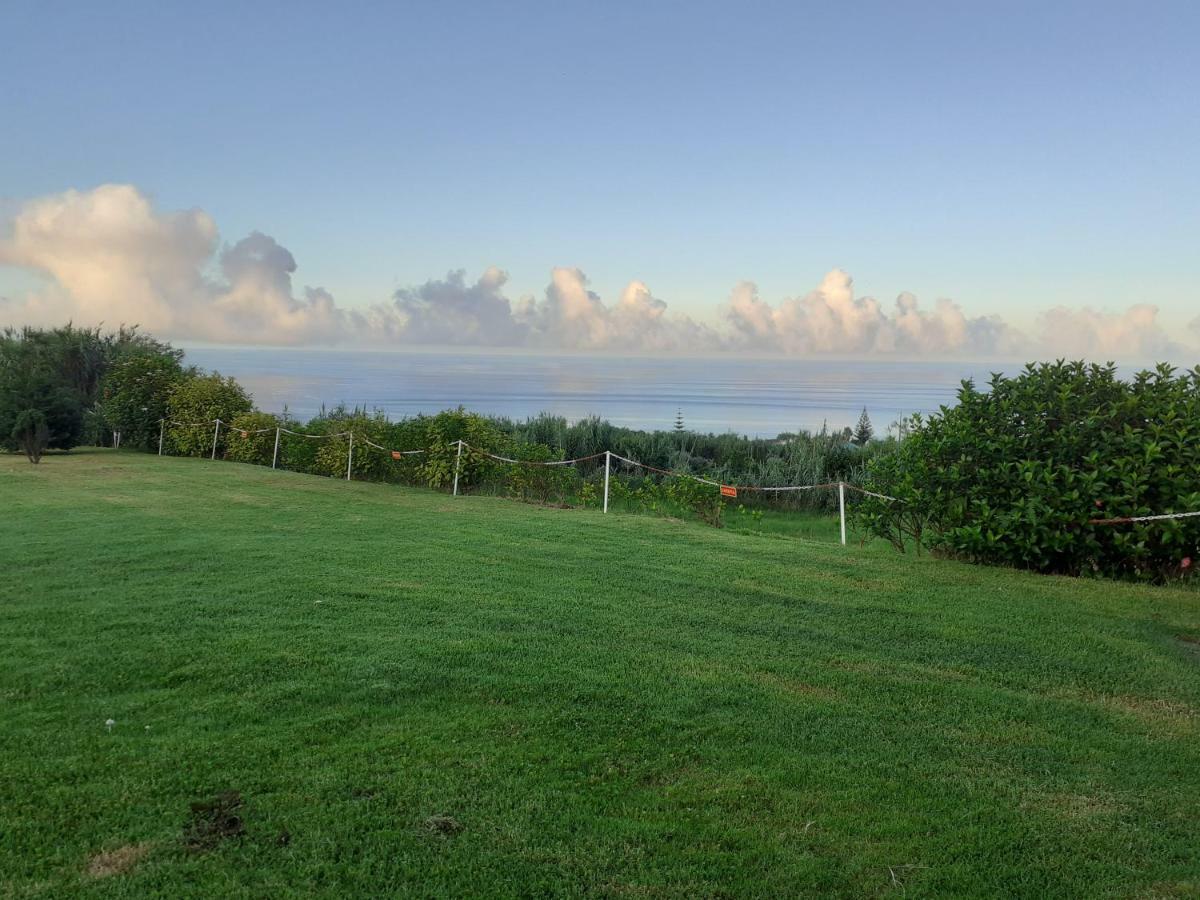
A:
186;348;1015;437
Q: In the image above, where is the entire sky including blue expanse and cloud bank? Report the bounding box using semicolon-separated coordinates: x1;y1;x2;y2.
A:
0;0;1200;361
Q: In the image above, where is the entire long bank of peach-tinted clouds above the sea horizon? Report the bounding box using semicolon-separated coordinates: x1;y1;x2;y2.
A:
0;185;1185;359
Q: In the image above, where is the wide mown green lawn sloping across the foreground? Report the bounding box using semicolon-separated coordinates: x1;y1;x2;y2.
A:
0;451;1200;898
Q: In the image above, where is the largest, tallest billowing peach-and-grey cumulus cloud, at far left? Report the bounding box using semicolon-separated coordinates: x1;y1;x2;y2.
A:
0;185;396;344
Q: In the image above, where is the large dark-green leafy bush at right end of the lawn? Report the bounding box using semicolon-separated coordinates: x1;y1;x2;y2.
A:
857;361;1200;581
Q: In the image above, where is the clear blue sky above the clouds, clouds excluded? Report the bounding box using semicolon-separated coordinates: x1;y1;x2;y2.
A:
0;1;1200;352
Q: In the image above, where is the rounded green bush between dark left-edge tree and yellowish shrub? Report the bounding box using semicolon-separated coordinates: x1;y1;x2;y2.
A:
100;352;185;450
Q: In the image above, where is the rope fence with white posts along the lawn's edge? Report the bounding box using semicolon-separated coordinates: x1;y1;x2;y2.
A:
138;419;1200;544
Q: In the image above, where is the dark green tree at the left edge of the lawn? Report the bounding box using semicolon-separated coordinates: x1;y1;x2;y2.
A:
0;330;83;463
